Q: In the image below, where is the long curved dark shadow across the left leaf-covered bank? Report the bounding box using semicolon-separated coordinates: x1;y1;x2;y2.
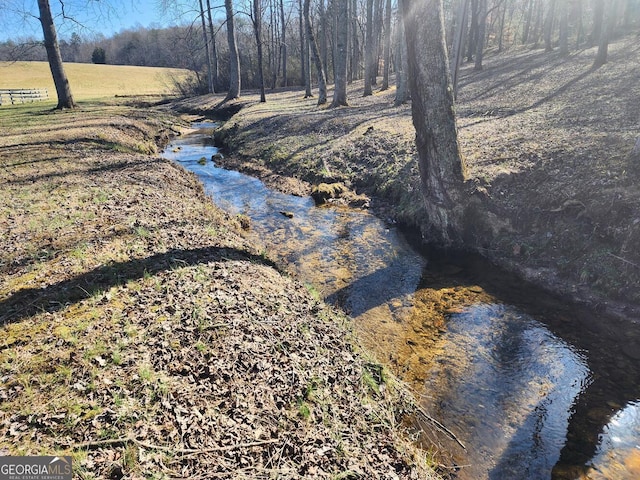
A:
0;247;277;325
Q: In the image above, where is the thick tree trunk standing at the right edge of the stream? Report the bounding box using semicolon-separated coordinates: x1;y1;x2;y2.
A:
405;0;466;246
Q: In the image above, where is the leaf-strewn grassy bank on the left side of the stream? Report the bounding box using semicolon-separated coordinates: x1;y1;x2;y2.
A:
0;106;440;479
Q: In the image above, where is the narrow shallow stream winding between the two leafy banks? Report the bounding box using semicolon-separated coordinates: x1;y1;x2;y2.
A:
164;123;640;480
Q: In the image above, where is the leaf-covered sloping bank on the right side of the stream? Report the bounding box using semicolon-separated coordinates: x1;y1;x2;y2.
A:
180;37;640;318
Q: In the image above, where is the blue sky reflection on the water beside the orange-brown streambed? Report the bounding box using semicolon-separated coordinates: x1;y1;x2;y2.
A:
424;304;589;479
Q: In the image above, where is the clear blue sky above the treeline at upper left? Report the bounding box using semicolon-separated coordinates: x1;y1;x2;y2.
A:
0;0;193;41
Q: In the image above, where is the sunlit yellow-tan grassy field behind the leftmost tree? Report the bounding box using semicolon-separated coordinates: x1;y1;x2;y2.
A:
0;62;190;102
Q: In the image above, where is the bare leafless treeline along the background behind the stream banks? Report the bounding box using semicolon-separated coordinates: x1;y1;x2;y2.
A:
0;0;640;91
